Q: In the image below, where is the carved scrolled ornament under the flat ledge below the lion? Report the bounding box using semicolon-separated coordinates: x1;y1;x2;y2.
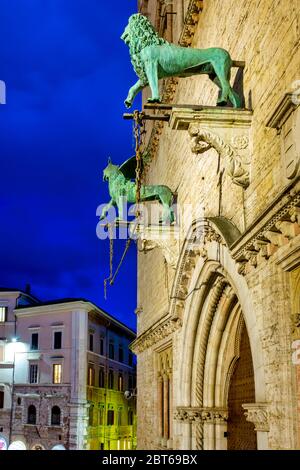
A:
189;124;250;188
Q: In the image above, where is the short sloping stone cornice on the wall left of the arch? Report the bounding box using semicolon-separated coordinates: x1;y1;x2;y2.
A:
130;317;182;354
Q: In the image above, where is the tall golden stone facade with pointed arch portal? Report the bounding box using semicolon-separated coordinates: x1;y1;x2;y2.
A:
132;0;300;449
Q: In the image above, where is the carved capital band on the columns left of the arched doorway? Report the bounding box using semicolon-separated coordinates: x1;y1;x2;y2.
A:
174;406;228;424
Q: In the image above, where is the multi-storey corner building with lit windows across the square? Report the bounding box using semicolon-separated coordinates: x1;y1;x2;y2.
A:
0;289;135;450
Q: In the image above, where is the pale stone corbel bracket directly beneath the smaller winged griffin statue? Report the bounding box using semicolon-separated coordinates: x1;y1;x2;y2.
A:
136;226;179;269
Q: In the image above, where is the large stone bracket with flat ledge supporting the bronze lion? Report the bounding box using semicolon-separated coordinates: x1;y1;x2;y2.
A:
170;107;252;189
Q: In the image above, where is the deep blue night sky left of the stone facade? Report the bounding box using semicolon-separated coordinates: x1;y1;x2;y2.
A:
0;0;140;327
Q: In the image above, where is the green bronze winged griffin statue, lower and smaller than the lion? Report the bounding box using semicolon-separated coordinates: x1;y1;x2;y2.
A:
100;157;174;223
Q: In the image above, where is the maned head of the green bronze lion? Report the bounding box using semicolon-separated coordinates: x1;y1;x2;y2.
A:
121;13;168;84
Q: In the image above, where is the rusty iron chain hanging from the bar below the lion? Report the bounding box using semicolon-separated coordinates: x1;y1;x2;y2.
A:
104;111;145;299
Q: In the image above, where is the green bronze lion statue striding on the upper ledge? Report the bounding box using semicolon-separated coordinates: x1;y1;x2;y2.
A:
121;13;242;108
